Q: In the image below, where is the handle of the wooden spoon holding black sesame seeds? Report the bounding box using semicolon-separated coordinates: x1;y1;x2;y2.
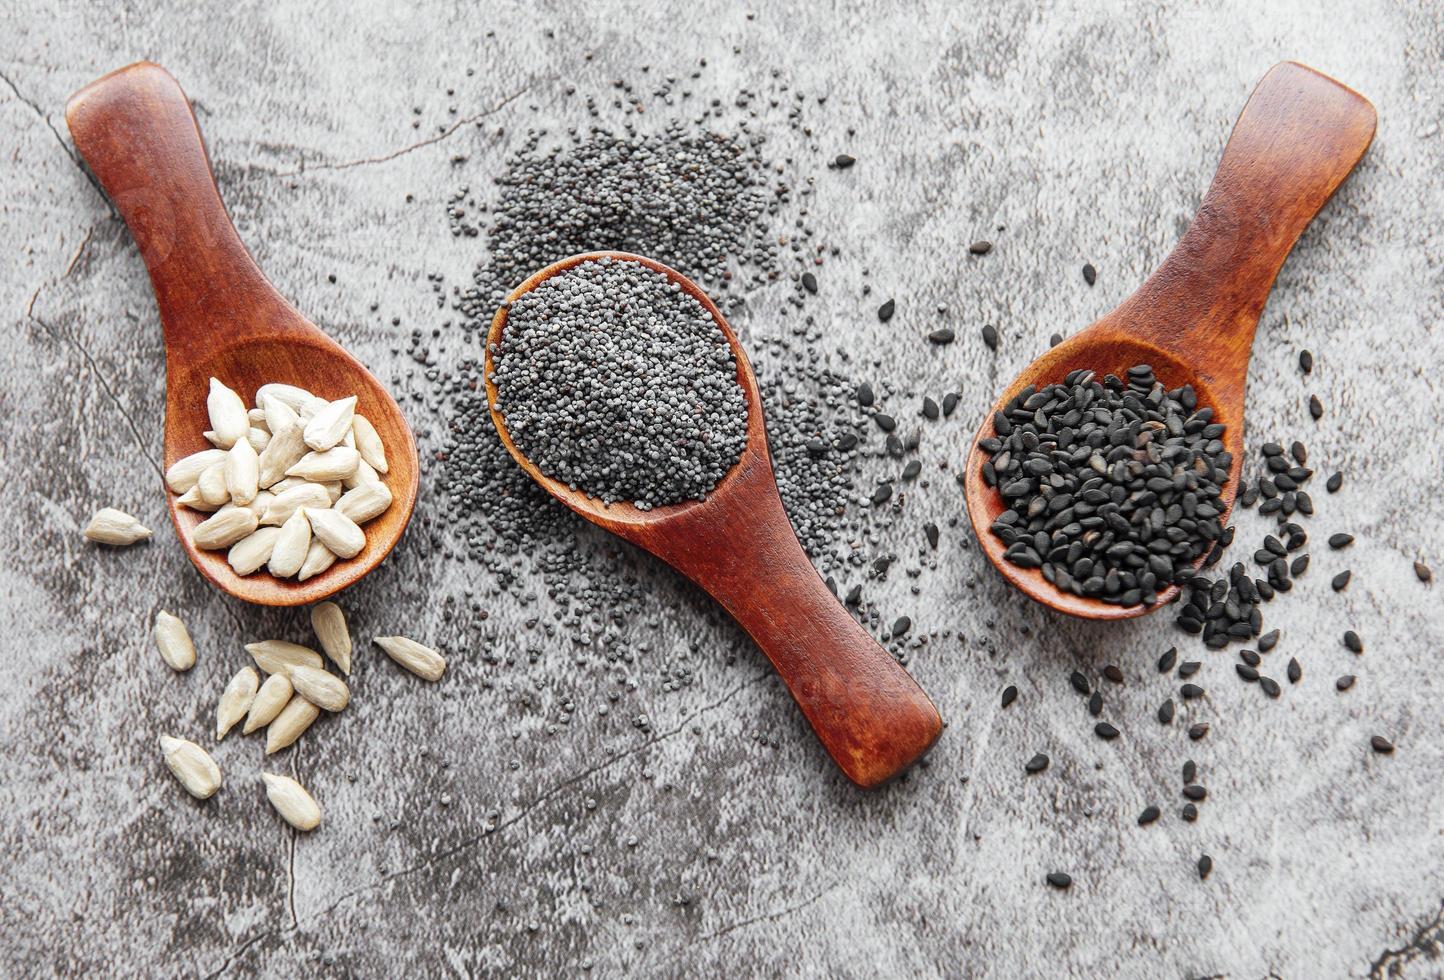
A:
1119;62;1376;356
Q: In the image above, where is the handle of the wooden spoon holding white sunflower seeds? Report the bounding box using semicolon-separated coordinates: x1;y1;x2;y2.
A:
65;62;290;354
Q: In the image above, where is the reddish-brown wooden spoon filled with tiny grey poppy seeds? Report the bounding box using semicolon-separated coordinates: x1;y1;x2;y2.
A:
485;253;943;788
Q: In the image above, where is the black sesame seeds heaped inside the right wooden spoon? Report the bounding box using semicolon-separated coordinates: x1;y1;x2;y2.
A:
980;364;1233;606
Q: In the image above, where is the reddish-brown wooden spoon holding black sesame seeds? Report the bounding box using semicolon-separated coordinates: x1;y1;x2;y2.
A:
966;62;1375;619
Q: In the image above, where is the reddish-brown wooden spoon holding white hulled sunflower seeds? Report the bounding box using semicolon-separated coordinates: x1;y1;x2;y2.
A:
65;62;419;606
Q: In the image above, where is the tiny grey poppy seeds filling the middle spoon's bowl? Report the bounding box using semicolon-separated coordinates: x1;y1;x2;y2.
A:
491;258;748;511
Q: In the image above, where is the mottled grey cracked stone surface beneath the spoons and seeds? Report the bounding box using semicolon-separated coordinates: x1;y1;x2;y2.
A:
0;0;1444;977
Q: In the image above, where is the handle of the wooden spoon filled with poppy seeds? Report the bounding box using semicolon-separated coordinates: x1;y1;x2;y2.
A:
658;482;943;788
